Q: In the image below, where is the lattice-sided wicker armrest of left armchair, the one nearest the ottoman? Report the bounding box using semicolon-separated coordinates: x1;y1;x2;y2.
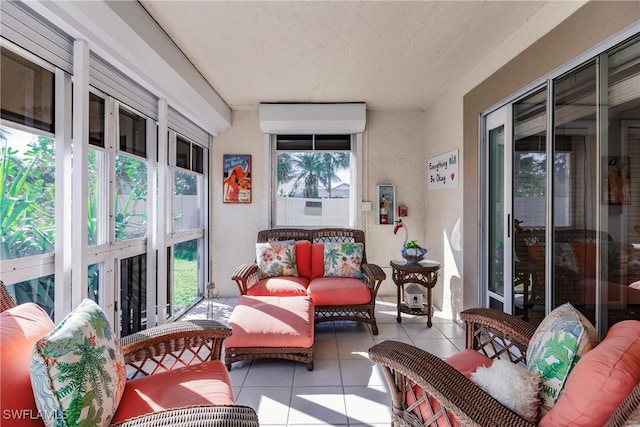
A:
120;320;231;377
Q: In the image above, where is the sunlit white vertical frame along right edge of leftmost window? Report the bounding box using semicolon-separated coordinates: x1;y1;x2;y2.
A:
54;69;73;322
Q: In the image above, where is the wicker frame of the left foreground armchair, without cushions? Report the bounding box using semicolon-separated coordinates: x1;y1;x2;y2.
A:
0;281;260;427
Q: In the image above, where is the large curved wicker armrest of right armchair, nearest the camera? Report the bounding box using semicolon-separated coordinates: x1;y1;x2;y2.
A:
369;341;534;427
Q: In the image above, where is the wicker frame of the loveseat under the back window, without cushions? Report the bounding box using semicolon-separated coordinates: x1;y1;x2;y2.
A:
231;228;386;335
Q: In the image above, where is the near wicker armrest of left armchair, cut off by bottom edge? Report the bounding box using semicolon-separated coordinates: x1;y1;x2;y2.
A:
112;405;260;427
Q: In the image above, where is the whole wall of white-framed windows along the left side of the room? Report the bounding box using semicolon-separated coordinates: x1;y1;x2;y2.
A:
0;9;210;335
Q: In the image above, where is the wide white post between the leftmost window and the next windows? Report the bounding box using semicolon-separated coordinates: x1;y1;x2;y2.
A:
71;40;89;307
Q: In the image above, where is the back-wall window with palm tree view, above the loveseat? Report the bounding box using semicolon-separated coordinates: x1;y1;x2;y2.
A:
273;135;355;227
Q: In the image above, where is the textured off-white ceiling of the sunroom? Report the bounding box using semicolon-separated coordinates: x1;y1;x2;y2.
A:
140;0;545;111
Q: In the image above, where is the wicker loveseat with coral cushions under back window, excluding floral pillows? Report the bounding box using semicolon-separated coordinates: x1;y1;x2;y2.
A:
232;228;386;335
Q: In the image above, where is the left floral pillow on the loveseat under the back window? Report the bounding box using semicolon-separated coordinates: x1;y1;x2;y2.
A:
256;240;298;277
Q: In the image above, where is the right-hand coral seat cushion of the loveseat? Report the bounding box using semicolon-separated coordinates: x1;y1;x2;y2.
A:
307;277;371;306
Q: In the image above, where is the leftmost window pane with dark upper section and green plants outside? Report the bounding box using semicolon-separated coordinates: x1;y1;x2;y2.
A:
0;47;56;318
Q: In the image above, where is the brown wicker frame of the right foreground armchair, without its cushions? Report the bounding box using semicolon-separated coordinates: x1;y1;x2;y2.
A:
369;309;640;427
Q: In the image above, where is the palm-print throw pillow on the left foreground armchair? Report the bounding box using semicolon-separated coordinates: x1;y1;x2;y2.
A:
31;299;126;427
